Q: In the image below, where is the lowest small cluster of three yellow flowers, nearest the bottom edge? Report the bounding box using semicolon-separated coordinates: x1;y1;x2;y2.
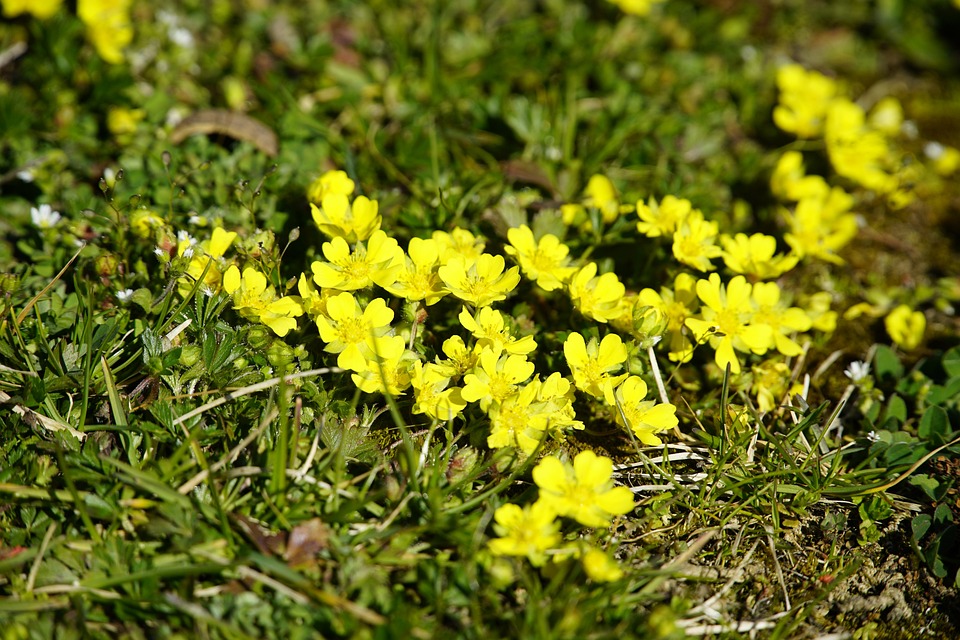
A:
489;451;634;581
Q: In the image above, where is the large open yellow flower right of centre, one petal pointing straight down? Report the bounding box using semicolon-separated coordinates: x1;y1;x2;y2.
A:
687;273;773;374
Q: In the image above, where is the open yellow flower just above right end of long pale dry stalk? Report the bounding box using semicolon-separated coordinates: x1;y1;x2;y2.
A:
316;291;404;372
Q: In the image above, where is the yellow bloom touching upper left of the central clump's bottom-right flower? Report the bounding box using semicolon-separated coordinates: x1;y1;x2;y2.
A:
563;332;627;404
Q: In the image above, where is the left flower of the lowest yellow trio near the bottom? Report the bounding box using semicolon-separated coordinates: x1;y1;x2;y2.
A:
490;502;561;567
